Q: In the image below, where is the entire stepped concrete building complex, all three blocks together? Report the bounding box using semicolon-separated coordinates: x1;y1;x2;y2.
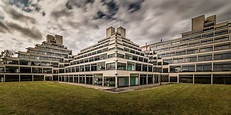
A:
0;15;231;88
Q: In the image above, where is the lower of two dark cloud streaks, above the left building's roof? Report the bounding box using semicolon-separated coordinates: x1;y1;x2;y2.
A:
6;22;42;40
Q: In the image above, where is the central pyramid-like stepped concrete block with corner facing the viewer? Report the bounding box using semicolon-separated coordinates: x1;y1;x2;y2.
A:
59;27;159;88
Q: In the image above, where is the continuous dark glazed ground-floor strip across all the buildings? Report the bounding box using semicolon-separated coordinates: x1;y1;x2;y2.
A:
0;72;231;87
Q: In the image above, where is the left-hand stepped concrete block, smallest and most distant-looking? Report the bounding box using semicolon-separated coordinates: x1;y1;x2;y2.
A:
0;35;72;82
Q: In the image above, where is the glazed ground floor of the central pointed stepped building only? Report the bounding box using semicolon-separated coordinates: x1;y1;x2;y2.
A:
58;73;160;87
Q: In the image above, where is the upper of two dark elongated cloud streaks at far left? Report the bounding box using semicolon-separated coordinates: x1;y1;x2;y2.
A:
4;7;37;24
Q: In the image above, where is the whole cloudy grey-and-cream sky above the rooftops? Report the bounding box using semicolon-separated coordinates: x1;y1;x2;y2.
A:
0;0;231;54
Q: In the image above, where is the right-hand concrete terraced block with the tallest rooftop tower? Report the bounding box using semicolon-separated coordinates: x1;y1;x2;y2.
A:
142;15;231;84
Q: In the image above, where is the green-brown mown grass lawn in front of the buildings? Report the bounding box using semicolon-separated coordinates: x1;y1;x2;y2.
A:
0;82;231;114
